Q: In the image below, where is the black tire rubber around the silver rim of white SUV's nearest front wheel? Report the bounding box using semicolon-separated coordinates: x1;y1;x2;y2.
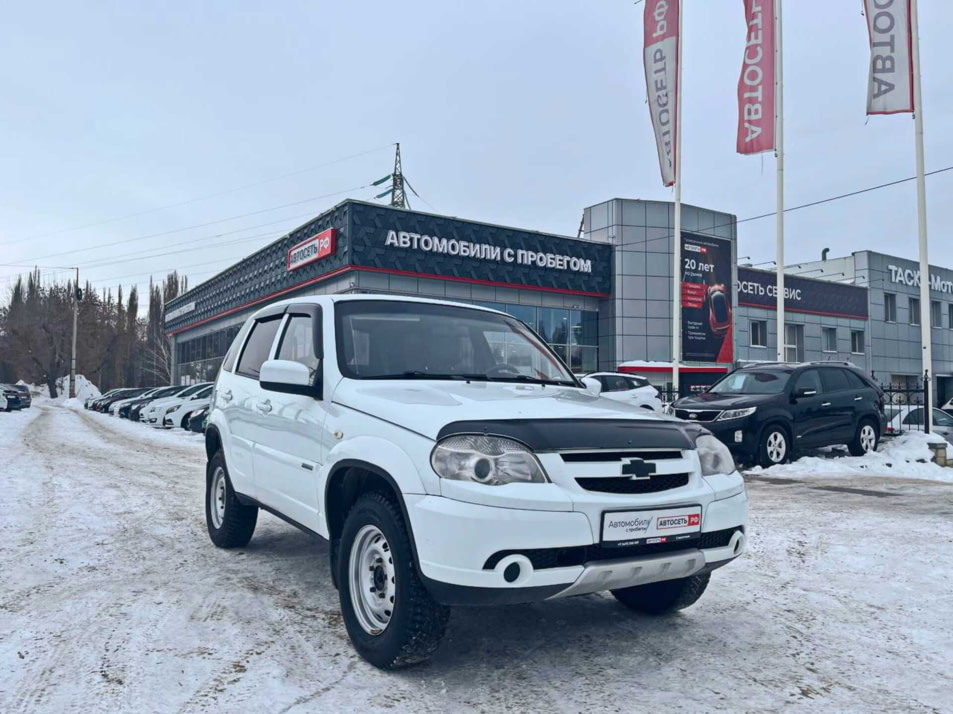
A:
336;493;450;669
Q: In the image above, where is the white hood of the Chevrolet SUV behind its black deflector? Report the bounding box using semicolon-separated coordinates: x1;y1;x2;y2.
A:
333;379;679;439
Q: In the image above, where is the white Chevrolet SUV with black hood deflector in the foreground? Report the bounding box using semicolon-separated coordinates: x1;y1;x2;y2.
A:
205;295;748;669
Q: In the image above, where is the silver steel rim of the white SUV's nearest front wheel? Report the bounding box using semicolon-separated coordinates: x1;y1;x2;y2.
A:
348;525;397;635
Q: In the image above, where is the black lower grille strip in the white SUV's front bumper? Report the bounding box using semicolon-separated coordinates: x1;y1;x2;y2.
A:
483;527;744;570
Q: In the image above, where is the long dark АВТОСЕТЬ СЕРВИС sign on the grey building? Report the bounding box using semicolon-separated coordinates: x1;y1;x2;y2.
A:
738;268;868;320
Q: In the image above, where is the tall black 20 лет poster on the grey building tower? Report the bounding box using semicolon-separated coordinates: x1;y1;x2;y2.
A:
681;232;734;363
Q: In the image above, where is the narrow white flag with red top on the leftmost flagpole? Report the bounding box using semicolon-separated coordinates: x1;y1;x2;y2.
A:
642;0;681;186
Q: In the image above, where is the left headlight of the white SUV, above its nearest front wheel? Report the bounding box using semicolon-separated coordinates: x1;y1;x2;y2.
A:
430;435;549;486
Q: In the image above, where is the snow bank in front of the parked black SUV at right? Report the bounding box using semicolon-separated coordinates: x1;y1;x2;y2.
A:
745;431;953;483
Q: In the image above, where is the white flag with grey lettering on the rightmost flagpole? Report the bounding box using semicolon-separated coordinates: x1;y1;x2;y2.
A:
864;0;913;114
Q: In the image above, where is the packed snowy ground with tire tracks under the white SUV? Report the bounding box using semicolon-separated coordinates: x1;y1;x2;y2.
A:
0;404;953;713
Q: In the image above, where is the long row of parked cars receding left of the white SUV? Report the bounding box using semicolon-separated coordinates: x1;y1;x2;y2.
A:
84;382;214;432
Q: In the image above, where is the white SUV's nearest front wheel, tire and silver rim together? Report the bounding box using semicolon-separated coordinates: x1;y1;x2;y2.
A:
337;493;450;669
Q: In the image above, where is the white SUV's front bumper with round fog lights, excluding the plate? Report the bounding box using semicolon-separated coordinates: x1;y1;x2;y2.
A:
406;491;748;605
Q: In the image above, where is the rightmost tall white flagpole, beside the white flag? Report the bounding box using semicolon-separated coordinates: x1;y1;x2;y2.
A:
910;0;933;434
